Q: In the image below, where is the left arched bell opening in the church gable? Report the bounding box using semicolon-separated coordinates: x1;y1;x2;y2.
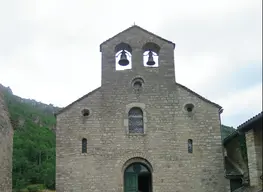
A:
115;43;132;70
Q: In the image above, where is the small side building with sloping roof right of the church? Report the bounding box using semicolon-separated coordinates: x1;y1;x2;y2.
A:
223;112;263;192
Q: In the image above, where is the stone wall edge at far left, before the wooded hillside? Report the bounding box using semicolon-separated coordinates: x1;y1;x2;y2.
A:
0;89;13;192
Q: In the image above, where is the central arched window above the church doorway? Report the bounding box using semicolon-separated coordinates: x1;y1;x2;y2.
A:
128;107;144;133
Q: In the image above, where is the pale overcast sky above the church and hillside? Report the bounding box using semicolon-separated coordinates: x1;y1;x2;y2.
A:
0;0;262;127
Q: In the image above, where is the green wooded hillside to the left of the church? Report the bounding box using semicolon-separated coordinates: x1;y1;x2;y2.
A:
1;87;57;192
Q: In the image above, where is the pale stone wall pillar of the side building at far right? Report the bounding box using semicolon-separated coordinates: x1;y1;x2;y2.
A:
246;127;262;189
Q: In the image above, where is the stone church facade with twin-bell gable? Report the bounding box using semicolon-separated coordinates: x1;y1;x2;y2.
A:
56;26;228;192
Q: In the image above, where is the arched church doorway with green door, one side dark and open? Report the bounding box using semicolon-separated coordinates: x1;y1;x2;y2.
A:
124;163;152;192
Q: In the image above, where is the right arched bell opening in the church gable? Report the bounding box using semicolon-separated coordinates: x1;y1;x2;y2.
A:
142;43;160;67
